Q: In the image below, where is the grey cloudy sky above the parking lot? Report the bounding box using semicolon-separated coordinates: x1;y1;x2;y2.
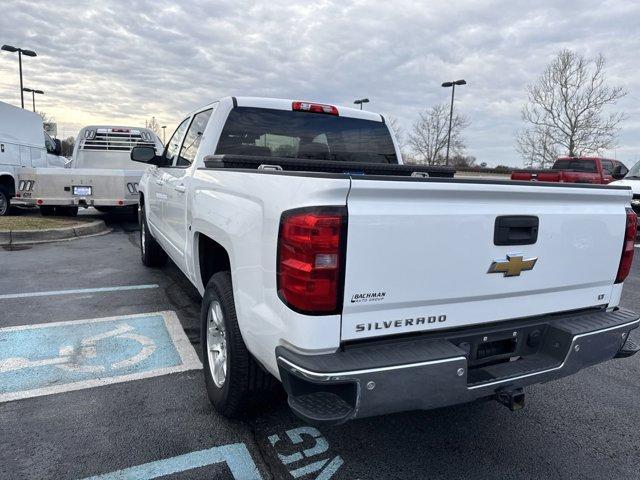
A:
0;0;640;165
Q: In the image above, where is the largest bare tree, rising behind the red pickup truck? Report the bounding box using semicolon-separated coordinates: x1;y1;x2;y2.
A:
517;50;627;165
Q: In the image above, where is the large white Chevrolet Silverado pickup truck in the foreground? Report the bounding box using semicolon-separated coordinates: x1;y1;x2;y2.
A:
131;97;639;424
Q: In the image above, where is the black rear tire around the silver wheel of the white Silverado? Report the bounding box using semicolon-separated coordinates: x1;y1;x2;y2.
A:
200;272;276;418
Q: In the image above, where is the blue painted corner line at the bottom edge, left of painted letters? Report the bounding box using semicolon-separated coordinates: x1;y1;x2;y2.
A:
85;443;262;480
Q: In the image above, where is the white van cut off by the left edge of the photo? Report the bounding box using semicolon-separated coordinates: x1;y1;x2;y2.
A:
0;102;65;216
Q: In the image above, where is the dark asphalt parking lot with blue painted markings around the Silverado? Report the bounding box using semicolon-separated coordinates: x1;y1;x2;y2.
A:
0;210;640;480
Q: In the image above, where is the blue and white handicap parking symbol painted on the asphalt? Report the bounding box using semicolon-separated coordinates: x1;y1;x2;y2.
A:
0;312;202;402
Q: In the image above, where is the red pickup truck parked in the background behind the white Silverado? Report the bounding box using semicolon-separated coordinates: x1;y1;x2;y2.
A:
511;157;629;184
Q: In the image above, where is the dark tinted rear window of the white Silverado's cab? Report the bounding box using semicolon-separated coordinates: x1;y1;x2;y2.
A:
216;107;398;163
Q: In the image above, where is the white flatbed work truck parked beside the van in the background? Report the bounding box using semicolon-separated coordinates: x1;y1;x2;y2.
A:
18;125;162;216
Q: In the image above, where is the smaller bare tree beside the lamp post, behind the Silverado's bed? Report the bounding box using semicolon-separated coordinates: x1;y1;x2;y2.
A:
407;104;470;165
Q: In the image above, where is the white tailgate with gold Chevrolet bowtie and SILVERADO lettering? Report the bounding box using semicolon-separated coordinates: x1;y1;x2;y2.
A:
341;178;630;340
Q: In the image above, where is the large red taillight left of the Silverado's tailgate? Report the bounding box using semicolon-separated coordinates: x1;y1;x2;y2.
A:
277;207;347;315
